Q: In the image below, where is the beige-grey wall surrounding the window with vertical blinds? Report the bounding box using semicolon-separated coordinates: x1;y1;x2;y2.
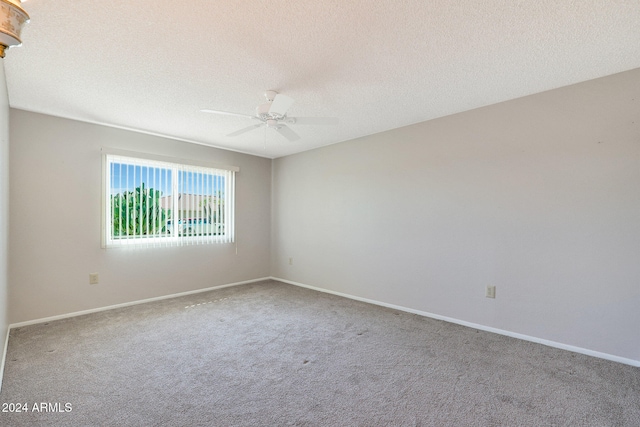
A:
9;110;271;323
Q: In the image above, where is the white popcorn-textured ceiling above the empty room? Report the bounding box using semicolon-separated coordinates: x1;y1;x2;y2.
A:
5;0;640;158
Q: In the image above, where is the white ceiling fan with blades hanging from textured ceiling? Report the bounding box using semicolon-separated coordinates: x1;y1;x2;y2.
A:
200;90;339;141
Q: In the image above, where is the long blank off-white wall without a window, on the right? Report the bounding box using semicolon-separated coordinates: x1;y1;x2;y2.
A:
271;70;640;361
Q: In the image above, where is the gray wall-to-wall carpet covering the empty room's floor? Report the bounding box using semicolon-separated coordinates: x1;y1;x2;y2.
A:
0;282;640;426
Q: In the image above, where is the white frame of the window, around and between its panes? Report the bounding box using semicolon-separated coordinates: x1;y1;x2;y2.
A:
101;148;240;248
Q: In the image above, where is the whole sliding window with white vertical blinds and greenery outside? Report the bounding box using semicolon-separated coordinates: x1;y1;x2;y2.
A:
103;154;238;247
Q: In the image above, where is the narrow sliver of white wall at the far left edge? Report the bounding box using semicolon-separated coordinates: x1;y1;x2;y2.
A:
0;61;9;386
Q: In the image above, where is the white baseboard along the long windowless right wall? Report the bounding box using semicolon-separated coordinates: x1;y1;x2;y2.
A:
271;277;640;367
